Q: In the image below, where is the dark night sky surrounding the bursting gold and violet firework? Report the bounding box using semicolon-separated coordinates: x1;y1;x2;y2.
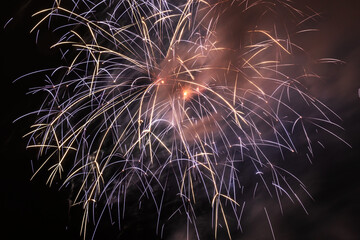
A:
0;0;360;239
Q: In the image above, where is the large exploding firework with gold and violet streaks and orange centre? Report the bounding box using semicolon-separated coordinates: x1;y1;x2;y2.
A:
18;0;348;238
